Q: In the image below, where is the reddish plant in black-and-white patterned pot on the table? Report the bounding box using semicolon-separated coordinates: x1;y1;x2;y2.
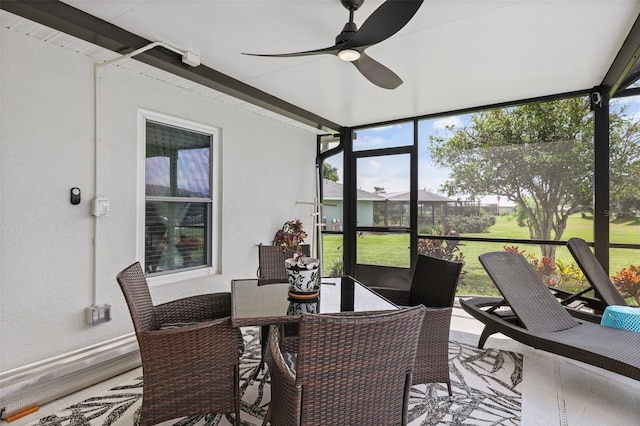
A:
273;219;320;293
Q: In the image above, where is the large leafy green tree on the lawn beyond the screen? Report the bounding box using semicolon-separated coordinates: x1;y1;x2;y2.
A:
430;98;639;259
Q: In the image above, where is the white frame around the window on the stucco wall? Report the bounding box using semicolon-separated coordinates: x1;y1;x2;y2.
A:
136;109;222;285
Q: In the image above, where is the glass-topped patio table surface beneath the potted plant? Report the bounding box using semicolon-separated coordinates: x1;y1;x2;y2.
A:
231;276;399;327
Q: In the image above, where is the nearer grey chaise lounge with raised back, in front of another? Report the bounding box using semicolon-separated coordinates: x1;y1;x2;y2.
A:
460;252;640;380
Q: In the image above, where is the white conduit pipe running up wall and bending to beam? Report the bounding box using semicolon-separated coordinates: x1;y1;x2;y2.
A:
91;41;200;306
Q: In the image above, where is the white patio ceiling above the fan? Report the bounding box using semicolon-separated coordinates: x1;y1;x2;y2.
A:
27;0;640;127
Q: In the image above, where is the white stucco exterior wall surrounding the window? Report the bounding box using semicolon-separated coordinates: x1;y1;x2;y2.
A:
0;28;316;371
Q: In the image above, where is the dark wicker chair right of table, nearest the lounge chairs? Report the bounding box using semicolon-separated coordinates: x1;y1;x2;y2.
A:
370;255;463;396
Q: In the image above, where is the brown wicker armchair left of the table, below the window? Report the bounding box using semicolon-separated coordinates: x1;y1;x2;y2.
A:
117;262;240;425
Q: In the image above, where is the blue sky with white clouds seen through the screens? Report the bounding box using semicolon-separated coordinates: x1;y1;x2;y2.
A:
328;96;640;205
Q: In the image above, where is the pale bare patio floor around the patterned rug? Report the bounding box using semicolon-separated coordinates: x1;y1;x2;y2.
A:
3;308;640;426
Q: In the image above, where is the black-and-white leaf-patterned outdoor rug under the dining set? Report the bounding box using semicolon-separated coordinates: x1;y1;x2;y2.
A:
29;328;523;426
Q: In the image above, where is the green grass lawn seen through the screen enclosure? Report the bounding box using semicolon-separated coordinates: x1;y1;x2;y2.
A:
323;214;640;295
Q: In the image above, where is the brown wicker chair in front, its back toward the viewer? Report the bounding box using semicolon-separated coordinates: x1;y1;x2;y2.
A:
265;306;425;426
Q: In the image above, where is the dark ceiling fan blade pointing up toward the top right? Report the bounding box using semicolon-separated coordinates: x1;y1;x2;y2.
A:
341;0;424;49
